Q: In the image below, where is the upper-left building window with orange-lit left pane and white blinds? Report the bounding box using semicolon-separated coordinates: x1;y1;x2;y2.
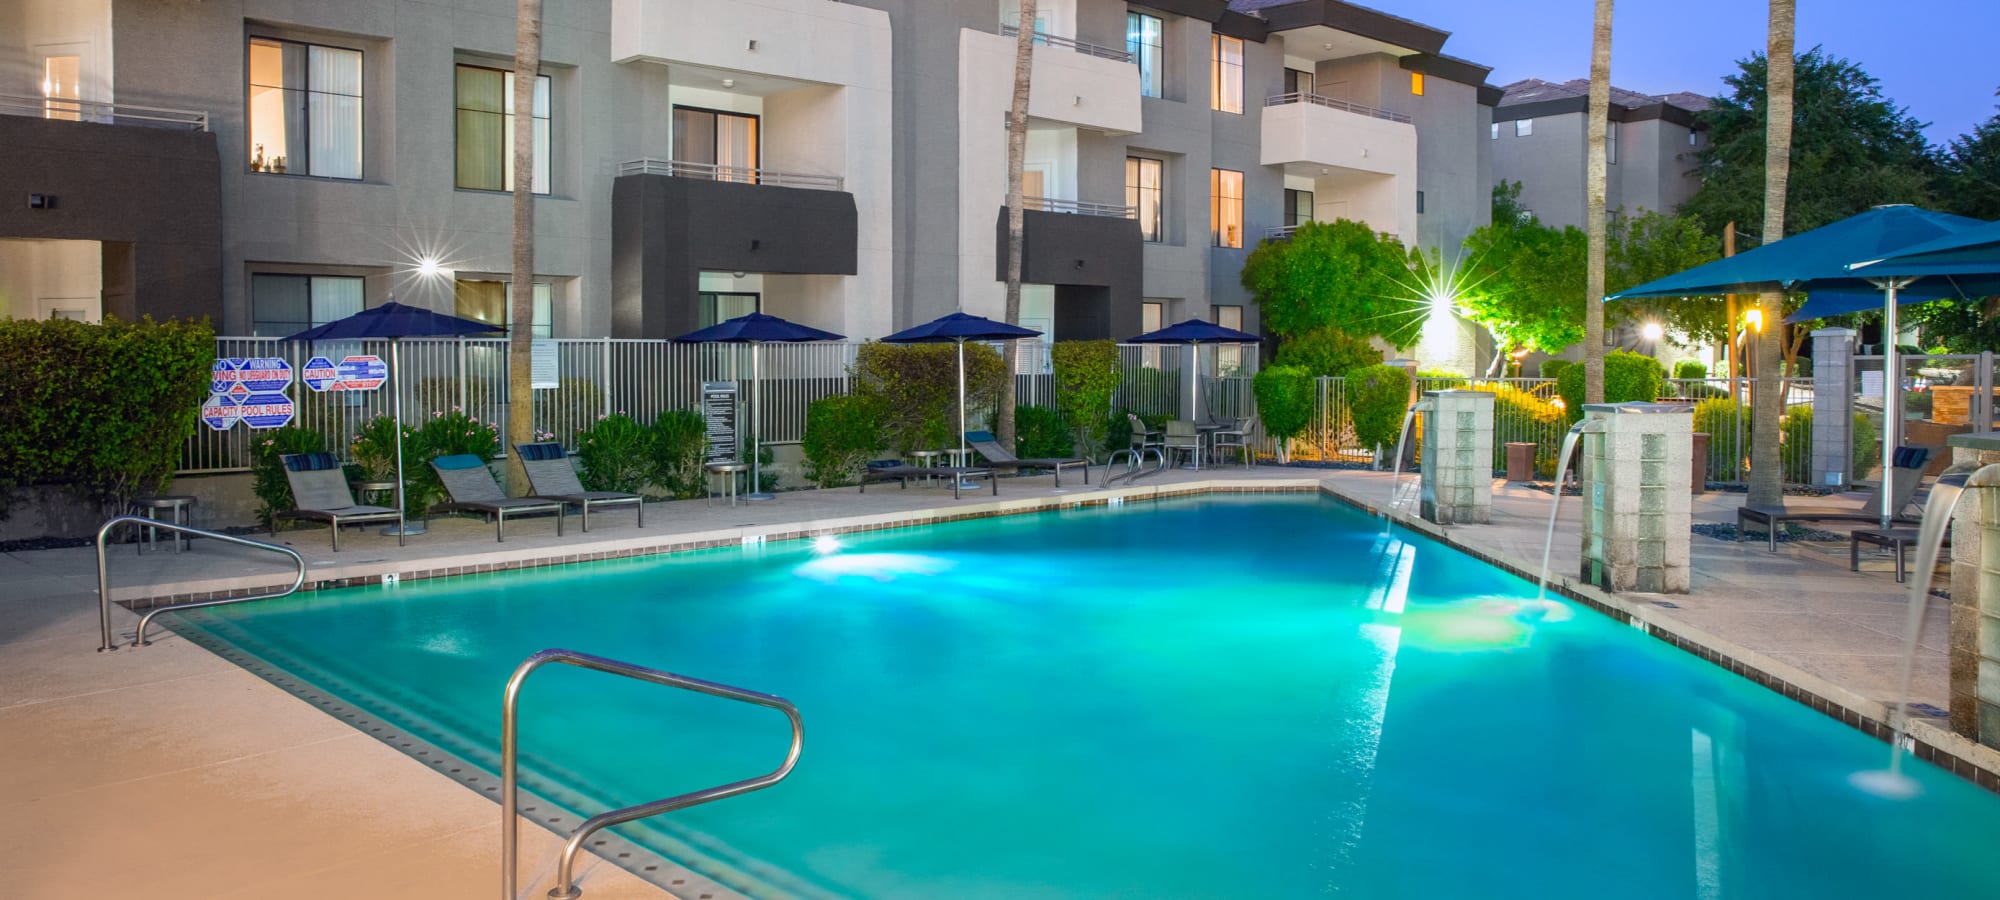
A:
246;38;362;178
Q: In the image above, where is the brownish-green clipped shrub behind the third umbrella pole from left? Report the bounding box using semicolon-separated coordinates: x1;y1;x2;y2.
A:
852;342;1008;454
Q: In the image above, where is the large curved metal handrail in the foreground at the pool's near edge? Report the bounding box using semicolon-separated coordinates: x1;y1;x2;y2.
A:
500;650;806;900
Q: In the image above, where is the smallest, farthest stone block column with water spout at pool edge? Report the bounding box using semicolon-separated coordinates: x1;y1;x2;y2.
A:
1420;390;1494;524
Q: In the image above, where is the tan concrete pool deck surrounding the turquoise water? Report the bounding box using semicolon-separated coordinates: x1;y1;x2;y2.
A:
0;466;2000;900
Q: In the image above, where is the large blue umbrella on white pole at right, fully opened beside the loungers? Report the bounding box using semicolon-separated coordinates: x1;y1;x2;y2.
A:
1604;204;1986;528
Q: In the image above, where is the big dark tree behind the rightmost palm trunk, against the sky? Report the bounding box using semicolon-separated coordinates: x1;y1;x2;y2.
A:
1680;48;1936;240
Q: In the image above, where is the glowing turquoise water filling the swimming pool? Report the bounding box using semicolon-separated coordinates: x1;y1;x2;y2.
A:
180;496;2000;900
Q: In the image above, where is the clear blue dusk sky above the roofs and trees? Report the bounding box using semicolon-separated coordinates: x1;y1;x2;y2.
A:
1392;0;2000;144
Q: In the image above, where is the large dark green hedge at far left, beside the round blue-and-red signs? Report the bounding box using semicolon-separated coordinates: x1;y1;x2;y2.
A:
0;316;216;512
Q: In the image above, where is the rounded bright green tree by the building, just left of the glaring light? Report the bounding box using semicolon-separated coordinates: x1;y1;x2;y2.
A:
1242;218;1428;346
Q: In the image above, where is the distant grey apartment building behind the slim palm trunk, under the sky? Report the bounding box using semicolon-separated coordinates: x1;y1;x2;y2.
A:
1486;78;1708;228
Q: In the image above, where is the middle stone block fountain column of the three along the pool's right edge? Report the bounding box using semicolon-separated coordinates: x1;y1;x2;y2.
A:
1580;402;1694;594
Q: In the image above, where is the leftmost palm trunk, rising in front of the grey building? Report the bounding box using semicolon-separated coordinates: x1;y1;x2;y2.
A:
506;0;542;496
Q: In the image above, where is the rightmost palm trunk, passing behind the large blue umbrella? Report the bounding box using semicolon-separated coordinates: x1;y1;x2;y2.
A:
1744;0;1800;506
